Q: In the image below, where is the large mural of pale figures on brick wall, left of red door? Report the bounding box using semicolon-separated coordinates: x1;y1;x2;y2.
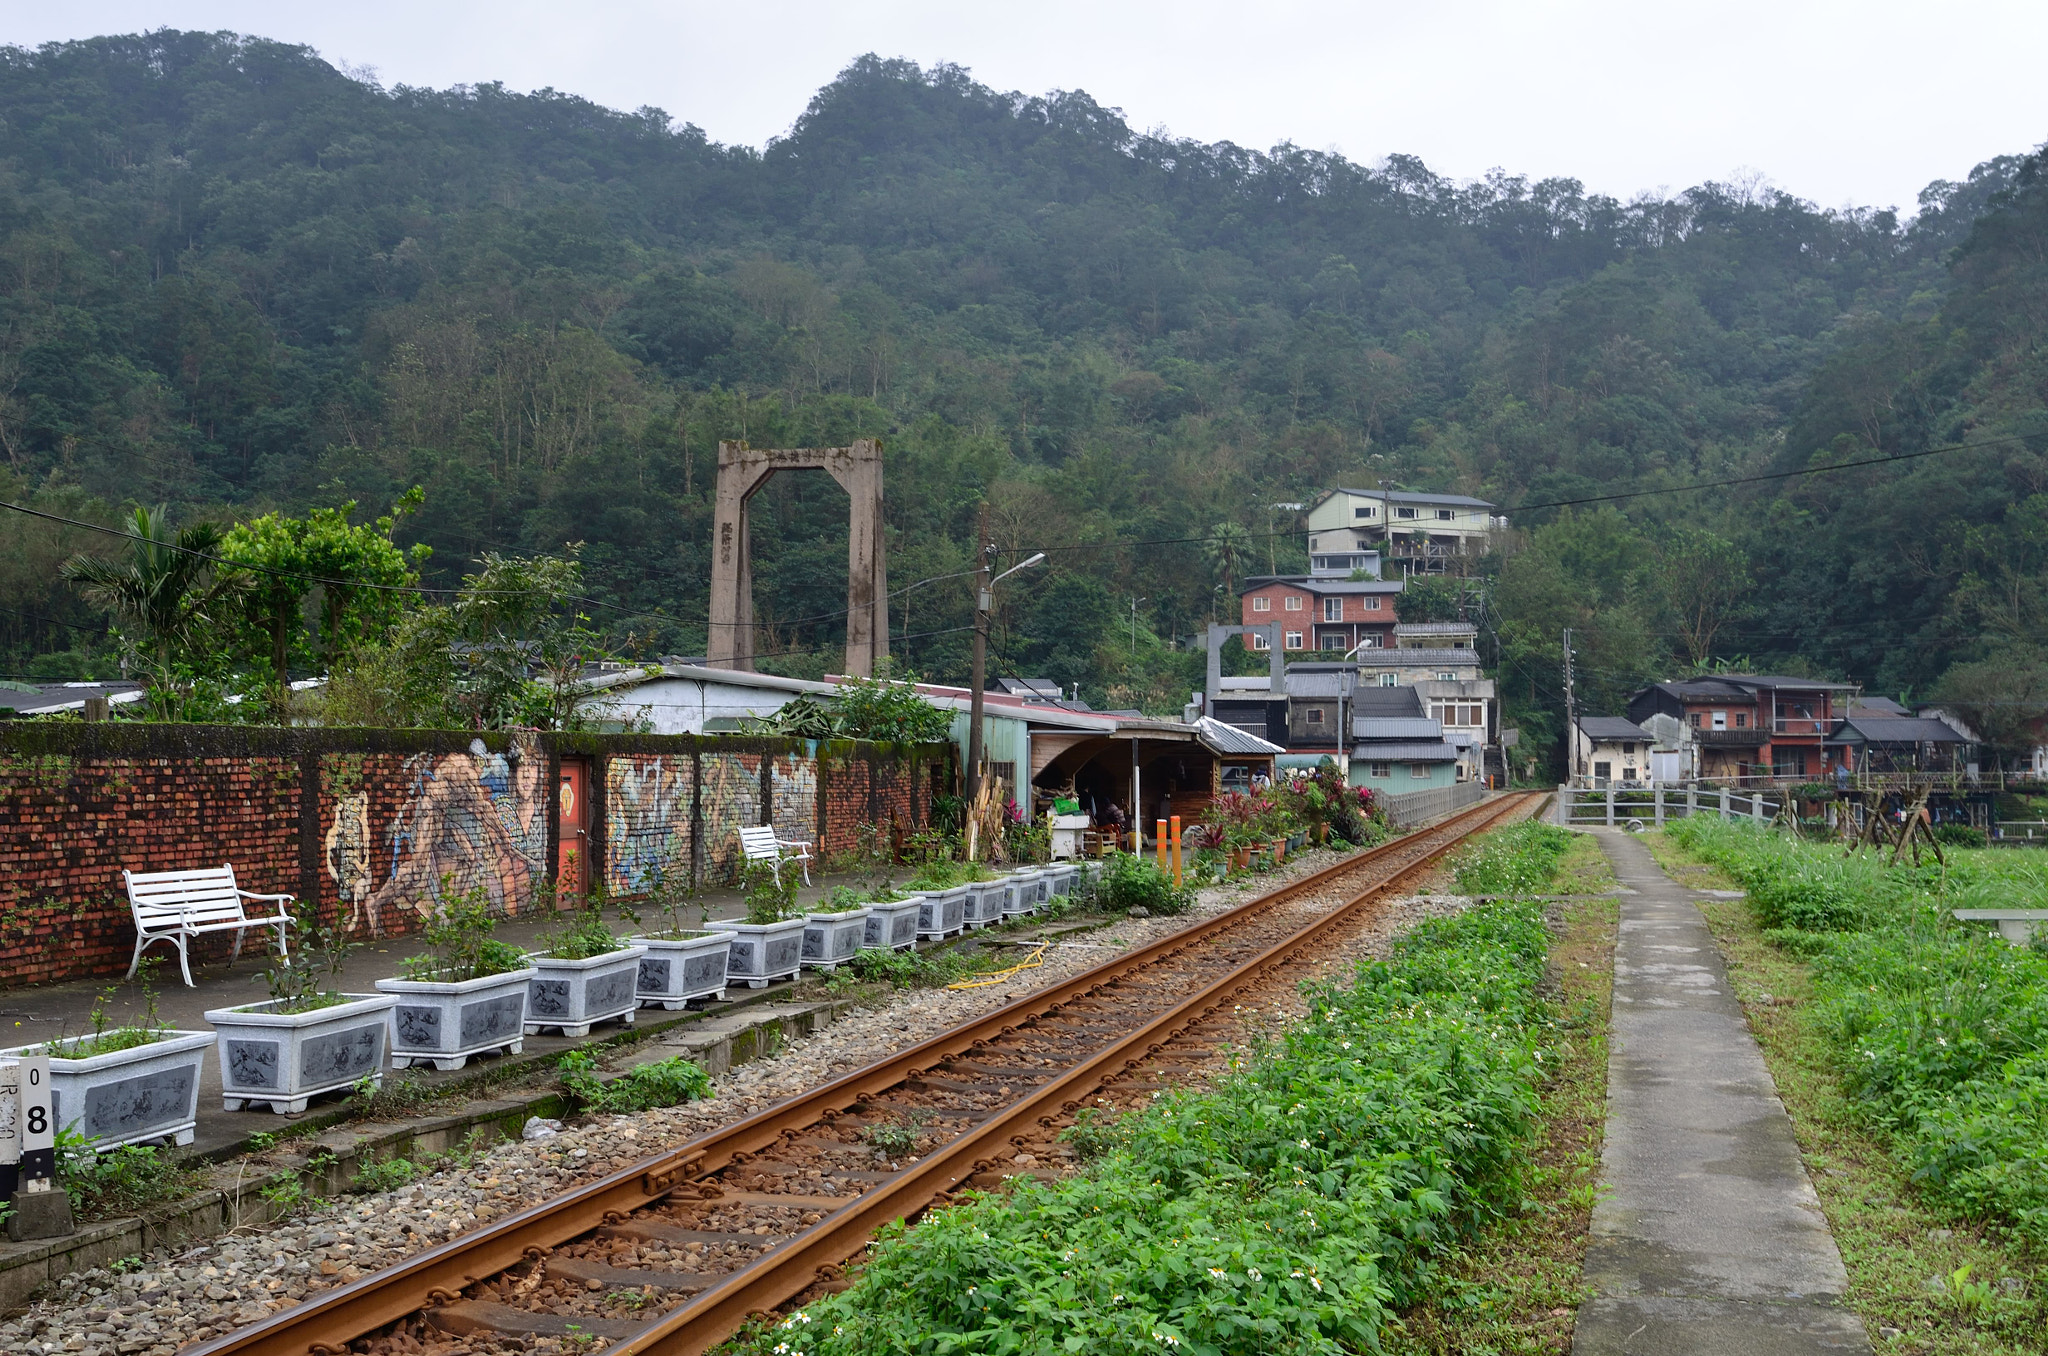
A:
354;737;547;918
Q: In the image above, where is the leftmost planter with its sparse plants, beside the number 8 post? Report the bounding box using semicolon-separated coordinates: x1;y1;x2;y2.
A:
0;959;213;1149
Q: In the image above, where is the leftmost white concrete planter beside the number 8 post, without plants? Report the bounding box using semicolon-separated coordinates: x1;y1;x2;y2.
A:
0;1030;213;1149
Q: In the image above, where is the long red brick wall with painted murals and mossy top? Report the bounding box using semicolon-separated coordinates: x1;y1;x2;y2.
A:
0;721;950;987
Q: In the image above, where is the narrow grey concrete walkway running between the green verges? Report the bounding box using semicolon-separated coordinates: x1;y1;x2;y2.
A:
1571;830;1870;1356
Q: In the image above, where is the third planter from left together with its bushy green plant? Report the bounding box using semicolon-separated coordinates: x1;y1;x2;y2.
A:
377;877;535;1069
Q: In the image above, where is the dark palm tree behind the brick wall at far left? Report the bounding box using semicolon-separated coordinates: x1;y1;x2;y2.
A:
59;504;240;686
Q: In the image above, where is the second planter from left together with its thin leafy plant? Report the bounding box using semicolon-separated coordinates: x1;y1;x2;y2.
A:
207;903;397;1114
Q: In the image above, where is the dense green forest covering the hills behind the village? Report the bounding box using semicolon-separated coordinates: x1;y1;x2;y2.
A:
0;31;2048;770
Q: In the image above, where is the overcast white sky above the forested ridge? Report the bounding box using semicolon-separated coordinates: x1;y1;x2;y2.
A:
0;0;2048;211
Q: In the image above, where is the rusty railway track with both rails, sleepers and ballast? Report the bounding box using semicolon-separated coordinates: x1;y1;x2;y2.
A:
180;797;1534;1356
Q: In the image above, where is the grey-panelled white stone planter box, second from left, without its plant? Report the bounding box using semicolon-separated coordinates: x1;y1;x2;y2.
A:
207;993;397;1114
